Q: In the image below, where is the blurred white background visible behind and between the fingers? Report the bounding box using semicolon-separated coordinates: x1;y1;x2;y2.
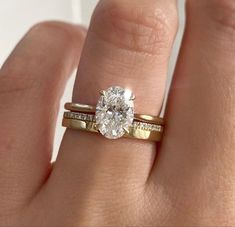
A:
0;0;185;159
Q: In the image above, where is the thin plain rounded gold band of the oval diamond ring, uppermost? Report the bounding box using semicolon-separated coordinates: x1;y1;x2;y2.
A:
64;103;164;125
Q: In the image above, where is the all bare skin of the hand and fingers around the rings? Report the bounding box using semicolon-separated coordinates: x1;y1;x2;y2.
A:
0;0;235;227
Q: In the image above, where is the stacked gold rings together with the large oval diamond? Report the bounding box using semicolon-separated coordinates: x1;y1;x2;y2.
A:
62;86;164;141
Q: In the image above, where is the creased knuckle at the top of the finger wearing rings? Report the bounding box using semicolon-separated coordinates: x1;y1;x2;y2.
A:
91;0;177;54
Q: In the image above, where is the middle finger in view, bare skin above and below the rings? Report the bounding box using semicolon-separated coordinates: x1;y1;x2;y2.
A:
41;0;177;220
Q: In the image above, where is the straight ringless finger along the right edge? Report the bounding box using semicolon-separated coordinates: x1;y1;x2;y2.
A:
152;0;235;222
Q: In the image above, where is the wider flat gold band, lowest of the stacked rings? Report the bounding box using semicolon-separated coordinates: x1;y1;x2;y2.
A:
62;118;163;141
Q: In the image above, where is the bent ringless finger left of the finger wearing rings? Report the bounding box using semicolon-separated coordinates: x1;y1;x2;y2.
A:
0;22;84;213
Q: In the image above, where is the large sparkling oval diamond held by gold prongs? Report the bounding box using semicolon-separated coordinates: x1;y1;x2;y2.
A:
95;86;134;139
